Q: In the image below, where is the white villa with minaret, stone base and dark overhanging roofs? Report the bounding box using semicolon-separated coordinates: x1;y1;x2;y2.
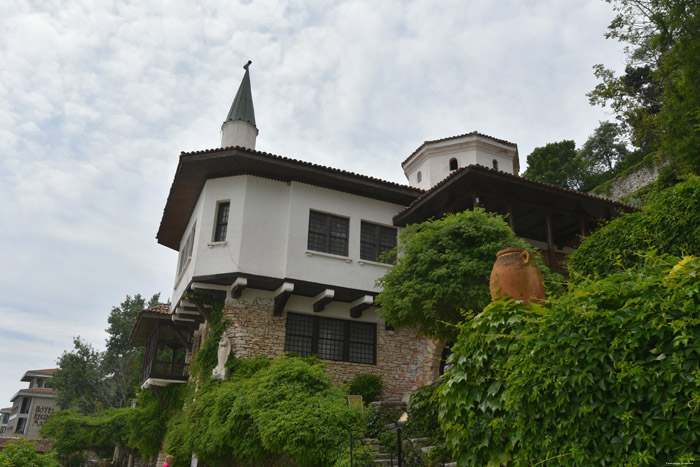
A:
131;66;632;400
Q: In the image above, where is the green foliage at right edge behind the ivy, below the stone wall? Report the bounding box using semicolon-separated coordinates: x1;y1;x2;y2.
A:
569;179;700;284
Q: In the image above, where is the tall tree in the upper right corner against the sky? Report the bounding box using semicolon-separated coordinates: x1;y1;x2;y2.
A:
589;0;700;173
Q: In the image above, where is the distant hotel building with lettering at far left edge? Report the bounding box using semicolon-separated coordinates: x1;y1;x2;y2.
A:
5;368;58;439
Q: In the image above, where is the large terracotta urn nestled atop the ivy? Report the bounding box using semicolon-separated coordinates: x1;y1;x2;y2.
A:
489;247;544;305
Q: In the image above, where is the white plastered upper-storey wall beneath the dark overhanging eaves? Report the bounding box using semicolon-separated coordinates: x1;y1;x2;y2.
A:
173;175;403;303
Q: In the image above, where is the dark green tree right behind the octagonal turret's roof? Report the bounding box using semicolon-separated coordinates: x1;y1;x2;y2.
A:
523;140;585;190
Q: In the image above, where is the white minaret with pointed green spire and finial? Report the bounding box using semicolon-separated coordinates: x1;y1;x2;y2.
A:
221;60;258;149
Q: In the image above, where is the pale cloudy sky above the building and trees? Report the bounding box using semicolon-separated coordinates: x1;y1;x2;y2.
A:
0;0;623;407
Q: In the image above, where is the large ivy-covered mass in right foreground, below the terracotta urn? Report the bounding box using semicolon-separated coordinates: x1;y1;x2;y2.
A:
440;256;700;466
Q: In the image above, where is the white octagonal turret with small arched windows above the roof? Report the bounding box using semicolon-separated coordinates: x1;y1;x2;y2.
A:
401;132;520;190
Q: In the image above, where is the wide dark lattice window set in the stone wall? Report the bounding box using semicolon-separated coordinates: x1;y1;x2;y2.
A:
284;313;377;365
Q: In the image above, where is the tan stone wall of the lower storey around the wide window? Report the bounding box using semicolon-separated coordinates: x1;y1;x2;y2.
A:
224;297;442;400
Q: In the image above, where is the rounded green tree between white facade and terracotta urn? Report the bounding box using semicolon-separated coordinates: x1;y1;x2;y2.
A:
377;209;546;340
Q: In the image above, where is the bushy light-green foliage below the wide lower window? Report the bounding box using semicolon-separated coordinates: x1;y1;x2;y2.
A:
166;357;359;466
